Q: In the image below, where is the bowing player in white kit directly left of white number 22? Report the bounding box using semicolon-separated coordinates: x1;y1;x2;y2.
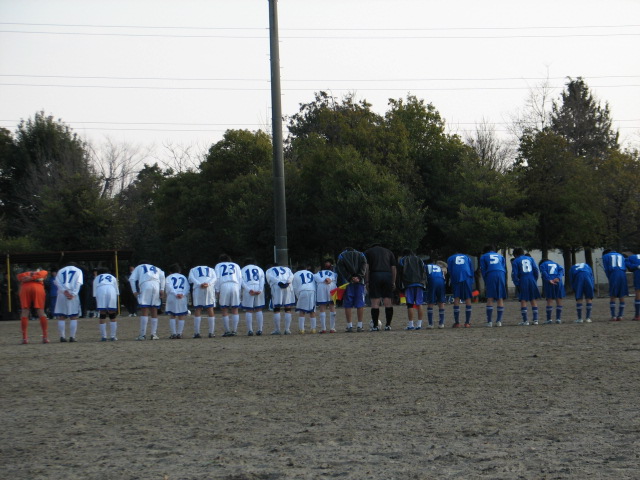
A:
129;262;165;340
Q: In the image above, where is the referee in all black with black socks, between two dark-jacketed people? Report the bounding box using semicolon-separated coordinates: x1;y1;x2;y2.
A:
364;243;397;332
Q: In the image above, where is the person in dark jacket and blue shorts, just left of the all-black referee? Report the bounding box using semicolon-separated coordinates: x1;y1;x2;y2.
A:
336;247;368;333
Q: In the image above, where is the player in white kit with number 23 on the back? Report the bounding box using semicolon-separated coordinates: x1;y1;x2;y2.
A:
216;253;242;337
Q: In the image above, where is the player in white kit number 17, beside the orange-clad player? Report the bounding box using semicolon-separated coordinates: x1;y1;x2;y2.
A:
54;263;84;342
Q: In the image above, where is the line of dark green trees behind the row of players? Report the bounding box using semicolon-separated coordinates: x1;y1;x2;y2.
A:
0;78;640;265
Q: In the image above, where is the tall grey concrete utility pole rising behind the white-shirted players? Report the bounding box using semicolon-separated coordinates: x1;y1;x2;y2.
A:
269;0;289;265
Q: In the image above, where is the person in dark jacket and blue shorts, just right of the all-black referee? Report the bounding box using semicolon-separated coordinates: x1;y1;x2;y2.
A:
398;248;427;330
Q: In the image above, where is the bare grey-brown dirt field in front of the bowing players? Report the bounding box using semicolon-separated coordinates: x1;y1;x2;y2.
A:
0;298;640;480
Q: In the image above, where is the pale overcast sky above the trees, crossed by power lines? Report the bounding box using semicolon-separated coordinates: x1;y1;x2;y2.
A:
0;0;640;161
